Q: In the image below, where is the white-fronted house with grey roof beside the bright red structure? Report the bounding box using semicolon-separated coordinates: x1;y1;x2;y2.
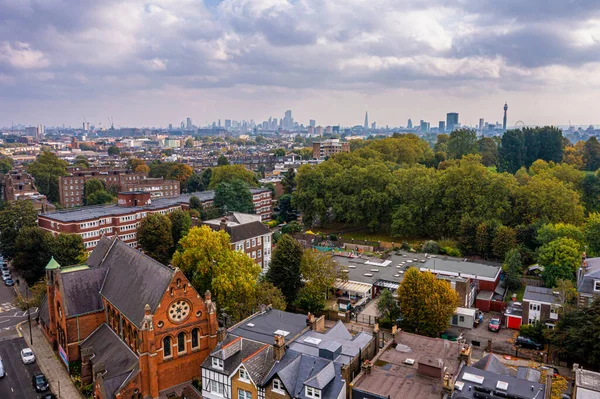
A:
521;285;561;328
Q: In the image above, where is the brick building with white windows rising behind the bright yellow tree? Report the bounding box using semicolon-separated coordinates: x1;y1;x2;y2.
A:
203;212;273;273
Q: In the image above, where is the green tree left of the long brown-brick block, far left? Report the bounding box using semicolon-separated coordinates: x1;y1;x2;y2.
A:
27;151;69;202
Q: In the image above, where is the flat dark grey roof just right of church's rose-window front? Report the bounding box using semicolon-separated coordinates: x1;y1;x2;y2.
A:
229;309;307;345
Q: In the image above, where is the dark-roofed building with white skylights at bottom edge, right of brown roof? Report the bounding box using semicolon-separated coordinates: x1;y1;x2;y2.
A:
451;354;550;399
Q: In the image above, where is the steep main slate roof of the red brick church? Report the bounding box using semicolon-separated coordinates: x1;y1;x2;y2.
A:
100;240;175;328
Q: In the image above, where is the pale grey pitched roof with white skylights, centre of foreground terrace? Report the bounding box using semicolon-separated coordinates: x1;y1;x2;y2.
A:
290;320;373;364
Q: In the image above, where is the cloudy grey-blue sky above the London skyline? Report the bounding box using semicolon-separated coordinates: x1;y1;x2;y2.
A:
0;0;600;126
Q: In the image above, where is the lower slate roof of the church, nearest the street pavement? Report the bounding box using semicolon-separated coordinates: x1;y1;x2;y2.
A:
80;323;139;398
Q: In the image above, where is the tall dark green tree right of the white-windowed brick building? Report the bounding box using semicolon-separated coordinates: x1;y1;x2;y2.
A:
266;234;303;303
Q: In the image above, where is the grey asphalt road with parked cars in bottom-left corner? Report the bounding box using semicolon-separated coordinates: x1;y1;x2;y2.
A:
0;337;40;399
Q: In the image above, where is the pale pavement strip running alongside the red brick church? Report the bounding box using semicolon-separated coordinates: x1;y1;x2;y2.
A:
18;323;83;399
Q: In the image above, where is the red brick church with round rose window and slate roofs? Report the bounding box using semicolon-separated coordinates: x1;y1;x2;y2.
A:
39;237;218;399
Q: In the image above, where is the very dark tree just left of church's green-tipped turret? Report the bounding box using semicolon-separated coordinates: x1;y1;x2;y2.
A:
12;227;52;285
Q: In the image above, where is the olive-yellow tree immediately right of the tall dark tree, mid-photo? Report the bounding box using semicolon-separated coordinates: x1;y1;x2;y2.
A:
296;250;340;313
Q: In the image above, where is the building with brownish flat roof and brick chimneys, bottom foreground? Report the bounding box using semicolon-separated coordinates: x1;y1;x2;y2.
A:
352;332;471;399
